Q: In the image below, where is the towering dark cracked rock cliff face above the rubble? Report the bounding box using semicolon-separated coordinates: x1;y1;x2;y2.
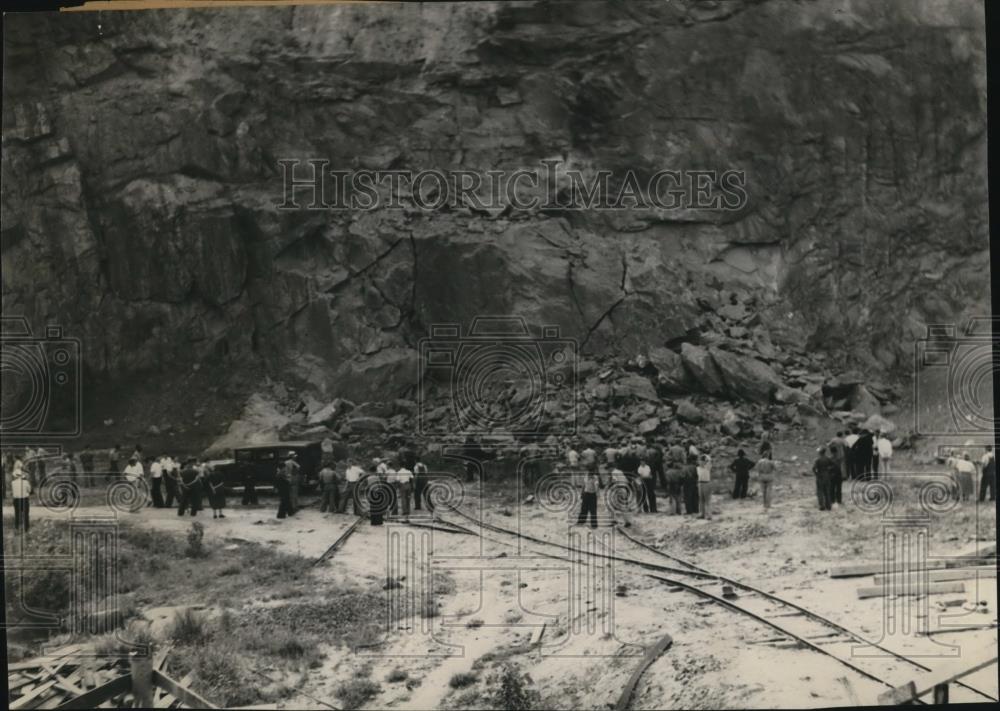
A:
3;0;989;436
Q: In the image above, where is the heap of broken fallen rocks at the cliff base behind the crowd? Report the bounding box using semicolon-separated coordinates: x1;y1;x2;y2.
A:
215;293;912;456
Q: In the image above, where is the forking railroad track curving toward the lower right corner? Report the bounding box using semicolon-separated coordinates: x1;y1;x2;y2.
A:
441;508;996;702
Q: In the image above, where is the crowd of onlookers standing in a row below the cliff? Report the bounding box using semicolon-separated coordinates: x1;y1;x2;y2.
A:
3;427;996;530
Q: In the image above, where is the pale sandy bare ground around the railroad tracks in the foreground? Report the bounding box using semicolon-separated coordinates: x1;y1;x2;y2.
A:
5;444;997;709
